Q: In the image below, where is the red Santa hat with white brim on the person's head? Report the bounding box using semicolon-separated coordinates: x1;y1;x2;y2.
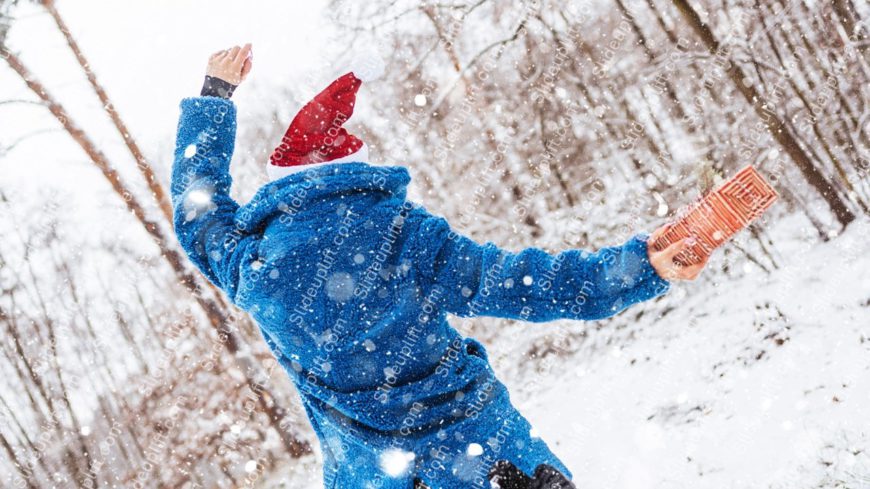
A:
268;72;368;179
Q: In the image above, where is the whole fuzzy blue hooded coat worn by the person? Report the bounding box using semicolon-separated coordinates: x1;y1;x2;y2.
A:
172;97;670;489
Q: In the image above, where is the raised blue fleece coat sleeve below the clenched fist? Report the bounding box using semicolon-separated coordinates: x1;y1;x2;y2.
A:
171;97;256;303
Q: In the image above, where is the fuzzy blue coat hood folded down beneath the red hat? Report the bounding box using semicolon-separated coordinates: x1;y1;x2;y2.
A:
235;162;411;232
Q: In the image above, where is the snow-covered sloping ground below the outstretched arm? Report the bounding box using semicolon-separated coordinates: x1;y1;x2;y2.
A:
262;217;870;489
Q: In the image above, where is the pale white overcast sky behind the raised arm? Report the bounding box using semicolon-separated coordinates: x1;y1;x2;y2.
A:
0;0;337;242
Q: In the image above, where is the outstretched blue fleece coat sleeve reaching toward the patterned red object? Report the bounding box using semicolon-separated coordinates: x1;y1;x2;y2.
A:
415;216;670;322
